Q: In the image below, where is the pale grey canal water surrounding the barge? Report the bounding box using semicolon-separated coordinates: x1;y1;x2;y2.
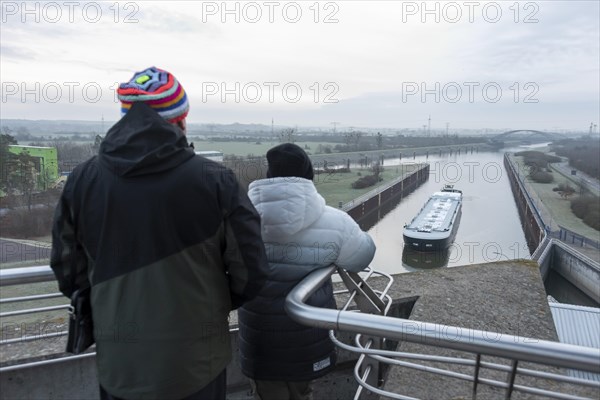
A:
368;148;531;273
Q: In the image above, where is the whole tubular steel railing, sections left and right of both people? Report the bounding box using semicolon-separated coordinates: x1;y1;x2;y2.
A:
0;266;600;399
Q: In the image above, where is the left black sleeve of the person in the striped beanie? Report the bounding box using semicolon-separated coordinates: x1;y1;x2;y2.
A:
50;174;89;297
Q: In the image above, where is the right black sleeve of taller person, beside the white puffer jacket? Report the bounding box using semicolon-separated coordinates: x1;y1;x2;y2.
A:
224;172;270;309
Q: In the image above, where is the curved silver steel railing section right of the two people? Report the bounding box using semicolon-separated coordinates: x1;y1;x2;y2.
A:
285;267;600;399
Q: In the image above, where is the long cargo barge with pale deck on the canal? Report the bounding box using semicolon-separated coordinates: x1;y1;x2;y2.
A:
403;185;462;251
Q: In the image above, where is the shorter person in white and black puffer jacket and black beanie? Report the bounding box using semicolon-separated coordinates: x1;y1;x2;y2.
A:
238;143;375;400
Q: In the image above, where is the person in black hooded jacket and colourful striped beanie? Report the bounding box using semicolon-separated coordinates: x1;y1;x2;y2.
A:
51;67;269;399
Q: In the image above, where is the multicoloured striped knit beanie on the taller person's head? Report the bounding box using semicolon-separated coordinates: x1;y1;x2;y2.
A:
117;67;190;123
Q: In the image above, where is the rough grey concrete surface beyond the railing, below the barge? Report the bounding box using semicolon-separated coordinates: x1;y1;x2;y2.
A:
366;260;600;399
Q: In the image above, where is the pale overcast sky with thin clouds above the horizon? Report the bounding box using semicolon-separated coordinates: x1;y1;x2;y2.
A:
0;0;600;131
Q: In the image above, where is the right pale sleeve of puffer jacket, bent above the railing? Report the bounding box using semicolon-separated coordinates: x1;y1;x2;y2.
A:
336;214;375;272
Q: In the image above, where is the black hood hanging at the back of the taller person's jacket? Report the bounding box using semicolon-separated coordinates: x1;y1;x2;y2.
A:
98;103;194;177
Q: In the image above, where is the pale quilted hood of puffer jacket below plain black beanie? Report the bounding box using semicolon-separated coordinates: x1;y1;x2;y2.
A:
248;177;325;241
